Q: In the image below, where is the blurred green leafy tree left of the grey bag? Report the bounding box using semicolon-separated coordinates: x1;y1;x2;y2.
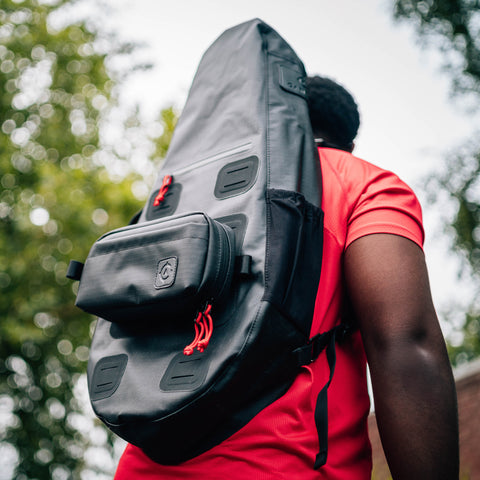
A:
0;0;175;480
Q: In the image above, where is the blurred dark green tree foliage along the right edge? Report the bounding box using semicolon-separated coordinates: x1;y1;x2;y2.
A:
394;0;480;364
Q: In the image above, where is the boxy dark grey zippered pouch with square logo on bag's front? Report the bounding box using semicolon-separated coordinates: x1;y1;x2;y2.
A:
76;213;235;322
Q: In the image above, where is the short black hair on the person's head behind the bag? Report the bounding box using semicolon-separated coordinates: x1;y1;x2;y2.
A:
306;75;360;150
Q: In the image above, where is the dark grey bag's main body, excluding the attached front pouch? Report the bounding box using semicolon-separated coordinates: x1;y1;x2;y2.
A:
88;19;323;468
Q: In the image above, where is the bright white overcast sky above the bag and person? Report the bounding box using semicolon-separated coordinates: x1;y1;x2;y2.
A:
99;0;473;322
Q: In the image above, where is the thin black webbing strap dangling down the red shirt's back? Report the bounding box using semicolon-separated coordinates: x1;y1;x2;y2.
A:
313;326;341;469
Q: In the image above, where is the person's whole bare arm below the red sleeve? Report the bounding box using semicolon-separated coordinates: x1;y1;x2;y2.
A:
344;234;459;480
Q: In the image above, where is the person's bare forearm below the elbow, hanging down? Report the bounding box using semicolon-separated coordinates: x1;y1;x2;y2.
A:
371;339;458;480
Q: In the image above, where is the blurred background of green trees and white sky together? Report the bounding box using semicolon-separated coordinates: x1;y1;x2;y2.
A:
0;0;480;480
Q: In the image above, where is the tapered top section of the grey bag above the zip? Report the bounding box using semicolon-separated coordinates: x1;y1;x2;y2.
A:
156;19;320;205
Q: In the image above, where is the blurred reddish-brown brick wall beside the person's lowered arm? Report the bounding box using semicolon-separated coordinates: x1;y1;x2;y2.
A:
368;359;480;480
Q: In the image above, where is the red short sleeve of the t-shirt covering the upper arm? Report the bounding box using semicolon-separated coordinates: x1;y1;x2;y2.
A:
345;164;424;248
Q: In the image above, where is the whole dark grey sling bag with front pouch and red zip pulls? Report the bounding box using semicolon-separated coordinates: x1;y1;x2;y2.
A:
69;19;340;467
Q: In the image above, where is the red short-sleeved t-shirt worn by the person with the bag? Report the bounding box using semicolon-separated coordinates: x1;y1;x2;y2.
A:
115;148;423;480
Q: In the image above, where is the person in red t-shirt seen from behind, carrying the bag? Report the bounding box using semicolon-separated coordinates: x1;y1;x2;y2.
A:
115;76;458;480
